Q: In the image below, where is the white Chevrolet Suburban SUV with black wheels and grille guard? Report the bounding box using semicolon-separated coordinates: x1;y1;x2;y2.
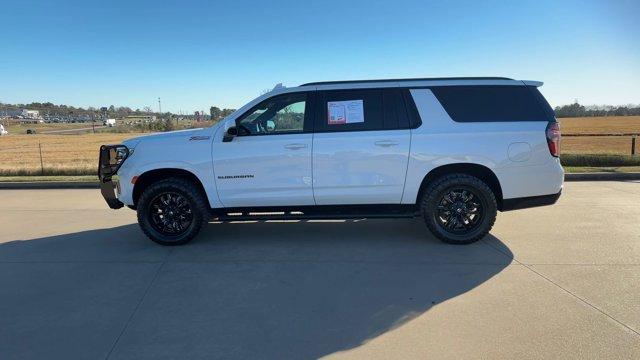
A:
99;78;564;245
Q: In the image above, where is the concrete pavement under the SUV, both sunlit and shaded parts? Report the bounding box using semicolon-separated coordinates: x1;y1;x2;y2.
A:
0;182;640;359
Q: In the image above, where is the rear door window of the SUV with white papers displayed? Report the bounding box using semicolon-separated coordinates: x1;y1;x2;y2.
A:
315;89;409;132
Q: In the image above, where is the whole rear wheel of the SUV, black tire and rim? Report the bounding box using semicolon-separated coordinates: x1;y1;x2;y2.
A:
420;174;497;244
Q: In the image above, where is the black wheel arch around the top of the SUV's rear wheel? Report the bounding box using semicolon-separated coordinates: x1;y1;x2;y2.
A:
416;163;503;211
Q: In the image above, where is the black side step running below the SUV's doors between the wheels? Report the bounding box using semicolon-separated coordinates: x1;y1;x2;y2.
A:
213;204;419;221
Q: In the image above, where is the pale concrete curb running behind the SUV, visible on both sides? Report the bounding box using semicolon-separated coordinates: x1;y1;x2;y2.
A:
0;172;640;190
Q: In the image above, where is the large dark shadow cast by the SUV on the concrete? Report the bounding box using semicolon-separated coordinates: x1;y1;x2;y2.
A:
0;220;513;359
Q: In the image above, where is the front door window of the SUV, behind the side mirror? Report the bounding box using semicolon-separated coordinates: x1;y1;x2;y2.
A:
238;93;307;135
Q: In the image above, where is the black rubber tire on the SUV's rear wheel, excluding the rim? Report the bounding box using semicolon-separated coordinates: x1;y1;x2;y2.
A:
420;174;498;245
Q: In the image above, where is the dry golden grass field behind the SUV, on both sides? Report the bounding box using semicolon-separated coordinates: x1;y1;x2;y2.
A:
0;116;640;176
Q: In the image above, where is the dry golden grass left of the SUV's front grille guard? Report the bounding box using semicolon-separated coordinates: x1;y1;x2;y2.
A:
0;133;144;176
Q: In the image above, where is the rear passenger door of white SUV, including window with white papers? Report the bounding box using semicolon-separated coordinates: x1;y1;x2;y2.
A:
313;88;411;205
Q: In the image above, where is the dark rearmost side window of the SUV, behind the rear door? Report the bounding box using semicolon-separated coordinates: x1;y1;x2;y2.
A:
431;86;550;122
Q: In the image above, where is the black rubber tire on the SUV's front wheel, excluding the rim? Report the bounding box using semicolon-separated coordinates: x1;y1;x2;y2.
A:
136;178;209;245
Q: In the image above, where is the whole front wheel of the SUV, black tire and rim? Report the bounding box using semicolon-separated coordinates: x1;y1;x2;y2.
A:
137;178;208;245
